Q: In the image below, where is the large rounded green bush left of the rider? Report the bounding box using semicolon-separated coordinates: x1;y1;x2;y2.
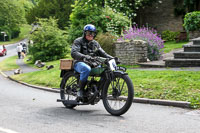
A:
29;18;68;61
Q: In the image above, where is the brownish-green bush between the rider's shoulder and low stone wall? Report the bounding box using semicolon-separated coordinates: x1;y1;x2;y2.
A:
96;32;117;56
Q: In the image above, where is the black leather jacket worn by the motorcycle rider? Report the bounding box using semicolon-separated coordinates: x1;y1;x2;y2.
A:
71;37;113;63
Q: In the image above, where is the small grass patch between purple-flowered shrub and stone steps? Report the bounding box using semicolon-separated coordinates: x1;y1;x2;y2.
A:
164;41;189;53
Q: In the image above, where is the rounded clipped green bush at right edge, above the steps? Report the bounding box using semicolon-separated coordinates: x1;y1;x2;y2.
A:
183;11;200;31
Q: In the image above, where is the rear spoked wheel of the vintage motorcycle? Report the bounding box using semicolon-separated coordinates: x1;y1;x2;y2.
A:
60;71;78;108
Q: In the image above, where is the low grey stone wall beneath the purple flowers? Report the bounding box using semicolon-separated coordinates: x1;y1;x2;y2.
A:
114;40;147;65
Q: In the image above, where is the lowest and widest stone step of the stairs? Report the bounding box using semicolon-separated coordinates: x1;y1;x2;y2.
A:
165;59;200;67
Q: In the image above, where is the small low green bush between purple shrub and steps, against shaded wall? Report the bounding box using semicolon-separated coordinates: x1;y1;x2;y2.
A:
161;30;180;41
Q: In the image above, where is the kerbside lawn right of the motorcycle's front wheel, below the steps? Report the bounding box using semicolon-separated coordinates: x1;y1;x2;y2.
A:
127;69;200;108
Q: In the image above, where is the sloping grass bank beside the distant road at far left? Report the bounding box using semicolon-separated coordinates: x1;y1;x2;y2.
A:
0;24;32;45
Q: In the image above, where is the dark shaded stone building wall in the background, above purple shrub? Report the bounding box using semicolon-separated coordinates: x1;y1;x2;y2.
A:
136;0;183;32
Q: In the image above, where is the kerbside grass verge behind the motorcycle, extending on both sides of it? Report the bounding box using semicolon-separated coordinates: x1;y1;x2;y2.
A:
12;55;200;108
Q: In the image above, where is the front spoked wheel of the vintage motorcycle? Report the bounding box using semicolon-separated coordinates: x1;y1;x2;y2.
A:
102;73;134;116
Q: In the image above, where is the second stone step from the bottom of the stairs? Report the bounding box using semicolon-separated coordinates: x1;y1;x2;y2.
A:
174;52;200;59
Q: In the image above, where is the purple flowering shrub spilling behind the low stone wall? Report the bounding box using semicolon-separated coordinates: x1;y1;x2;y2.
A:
118;26;164;61
